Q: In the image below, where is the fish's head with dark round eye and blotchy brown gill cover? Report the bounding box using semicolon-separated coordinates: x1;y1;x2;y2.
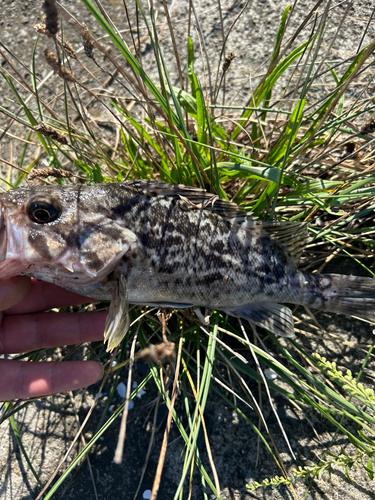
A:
0;186;136;288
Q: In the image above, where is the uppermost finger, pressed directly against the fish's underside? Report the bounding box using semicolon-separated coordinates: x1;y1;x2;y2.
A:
6;279;102;314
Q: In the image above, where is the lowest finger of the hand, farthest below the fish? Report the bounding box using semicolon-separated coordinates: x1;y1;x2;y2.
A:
0;359;103;401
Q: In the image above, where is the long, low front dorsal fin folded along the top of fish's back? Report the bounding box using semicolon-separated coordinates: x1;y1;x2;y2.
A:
126;180;248;223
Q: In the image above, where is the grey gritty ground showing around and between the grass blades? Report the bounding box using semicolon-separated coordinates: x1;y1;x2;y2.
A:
0;0;375;500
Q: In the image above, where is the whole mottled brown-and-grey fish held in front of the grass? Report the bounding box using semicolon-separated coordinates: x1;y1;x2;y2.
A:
0;180;375;350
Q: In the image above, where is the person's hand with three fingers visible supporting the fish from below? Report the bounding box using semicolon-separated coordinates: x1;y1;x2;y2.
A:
0;276;107;401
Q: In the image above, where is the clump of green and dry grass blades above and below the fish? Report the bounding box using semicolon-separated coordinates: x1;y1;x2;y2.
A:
0;0;375;499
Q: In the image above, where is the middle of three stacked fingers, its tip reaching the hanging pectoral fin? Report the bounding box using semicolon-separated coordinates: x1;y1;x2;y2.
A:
0;312;107;354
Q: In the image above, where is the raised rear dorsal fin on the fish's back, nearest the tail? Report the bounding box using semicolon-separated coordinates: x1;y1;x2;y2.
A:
242;220;309;267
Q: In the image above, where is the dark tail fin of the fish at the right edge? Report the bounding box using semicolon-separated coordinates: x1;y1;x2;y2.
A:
311;274;375;320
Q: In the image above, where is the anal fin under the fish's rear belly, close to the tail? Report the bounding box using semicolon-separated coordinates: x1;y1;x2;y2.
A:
224;302;295;338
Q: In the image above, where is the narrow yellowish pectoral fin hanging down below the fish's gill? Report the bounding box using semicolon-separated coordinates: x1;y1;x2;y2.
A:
104;270;130;352
